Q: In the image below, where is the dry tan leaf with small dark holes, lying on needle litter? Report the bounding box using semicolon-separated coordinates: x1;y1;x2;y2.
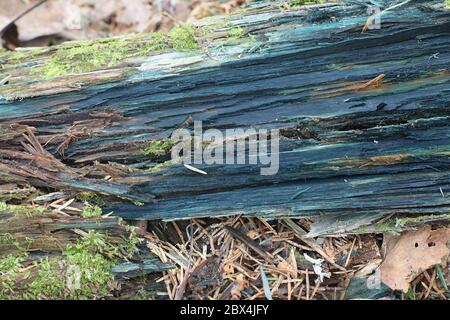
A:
380;226;450;292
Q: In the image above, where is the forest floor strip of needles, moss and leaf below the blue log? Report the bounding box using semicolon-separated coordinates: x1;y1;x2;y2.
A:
0;188;450;300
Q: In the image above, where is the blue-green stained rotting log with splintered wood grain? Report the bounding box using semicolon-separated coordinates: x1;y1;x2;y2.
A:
0;1;450;233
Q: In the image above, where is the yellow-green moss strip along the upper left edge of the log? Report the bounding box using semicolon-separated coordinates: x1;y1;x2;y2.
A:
0;25;200;78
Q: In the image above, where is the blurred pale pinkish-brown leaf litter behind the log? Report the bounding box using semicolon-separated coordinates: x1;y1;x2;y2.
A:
0;0;246;50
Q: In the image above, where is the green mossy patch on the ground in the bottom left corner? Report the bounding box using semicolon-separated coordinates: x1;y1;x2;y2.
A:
0;230;138;300
